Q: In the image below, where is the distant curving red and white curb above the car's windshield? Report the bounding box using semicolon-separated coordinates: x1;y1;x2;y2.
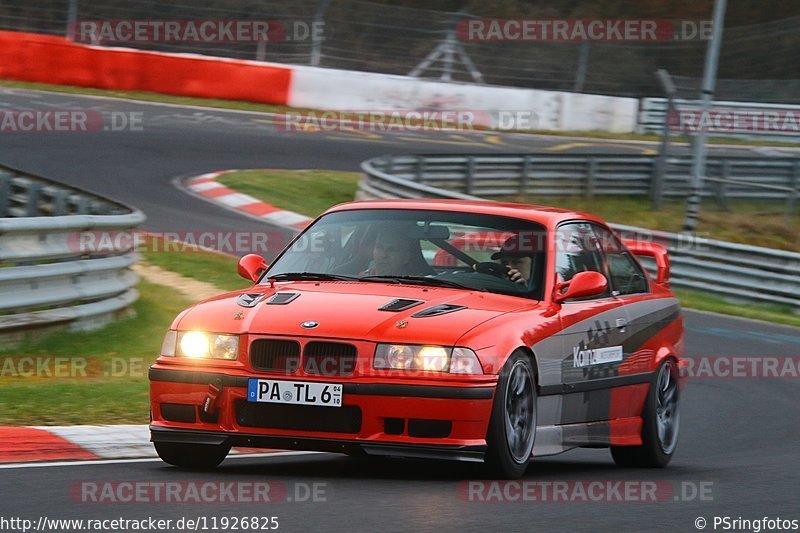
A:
183;170;312;231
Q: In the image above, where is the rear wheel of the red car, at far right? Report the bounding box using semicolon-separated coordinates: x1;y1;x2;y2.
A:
611;359;681;468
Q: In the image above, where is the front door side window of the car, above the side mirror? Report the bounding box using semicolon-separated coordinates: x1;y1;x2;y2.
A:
555;223;608;296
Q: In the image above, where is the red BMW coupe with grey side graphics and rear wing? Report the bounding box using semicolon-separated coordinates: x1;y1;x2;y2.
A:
149;200;684;478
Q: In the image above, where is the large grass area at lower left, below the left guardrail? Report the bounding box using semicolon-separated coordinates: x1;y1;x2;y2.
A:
0;281;190;425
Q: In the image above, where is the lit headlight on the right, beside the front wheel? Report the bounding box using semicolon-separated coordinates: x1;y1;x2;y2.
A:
372;344;483;374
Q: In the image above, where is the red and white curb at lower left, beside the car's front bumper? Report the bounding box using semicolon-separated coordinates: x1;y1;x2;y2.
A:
0;425;270;464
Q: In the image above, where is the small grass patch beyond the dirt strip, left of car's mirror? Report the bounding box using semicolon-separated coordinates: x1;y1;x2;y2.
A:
142;234;245;291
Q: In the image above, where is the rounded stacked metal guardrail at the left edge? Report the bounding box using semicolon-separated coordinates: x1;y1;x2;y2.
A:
0;166;145;336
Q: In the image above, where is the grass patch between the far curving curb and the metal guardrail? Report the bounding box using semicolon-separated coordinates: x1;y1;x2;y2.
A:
217;170;360;217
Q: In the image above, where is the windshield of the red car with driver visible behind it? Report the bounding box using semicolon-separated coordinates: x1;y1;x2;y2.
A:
261;209;546;300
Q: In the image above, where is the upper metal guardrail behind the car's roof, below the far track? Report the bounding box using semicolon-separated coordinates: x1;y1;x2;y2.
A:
365;154;800;206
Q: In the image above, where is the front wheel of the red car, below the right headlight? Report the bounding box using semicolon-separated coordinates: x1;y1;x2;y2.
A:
485;352;536;479
